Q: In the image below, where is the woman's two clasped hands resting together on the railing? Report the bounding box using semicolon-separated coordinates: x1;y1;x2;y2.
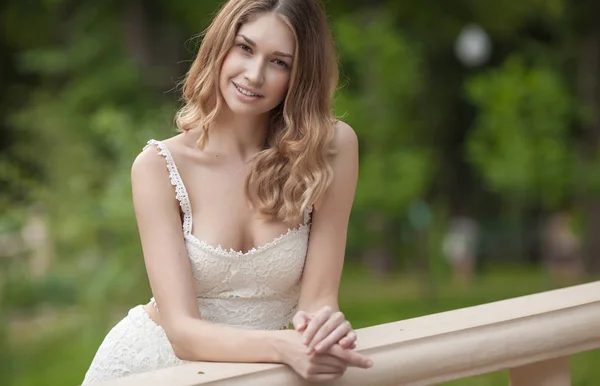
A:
286;306;373;382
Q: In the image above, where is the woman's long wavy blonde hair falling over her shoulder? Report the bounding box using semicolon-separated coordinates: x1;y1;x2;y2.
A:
176;0;338;224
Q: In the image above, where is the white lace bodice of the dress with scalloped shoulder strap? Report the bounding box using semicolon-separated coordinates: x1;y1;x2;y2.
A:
144;140;310;330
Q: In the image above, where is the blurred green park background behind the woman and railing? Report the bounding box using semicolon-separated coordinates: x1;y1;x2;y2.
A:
0;0;600;386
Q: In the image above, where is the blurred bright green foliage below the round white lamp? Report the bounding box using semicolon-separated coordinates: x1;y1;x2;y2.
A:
467;58;574;209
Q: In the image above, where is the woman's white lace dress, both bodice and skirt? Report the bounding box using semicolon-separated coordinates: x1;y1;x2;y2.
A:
83;140;310;385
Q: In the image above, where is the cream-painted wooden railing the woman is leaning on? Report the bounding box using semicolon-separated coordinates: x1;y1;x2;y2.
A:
103;282;600;386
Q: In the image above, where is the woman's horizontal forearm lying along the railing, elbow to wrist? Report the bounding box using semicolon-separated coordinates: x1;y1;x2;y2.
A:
168;318;284;363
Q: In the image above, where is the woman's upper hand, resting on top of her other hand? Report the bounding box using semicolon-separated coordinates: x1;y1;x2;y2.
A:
293;306;357;354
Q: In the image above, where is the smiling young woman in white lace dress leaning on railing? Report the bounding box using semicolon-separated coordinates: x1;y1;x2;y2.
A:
79;0;372;384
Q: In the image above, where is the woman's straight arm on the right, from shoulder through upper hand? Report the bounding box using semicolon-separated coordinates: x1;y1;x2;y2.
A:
298;121;358;347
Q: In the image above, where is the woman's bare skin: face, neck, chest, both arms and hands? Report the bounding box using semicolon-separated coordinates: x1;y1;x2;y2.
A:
131;13;372;381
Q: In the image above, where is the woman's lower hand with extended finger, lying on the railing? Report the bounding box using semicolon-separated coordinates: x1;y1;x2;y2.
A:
277;330;372;382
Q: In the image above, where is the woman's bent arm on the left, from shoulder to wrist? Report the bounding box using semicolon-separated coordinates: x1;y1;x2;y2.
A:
131;147;281;362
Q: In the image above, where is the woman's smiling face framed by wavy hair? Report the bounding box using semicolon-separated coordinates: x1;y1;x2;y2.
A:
219;13;296;115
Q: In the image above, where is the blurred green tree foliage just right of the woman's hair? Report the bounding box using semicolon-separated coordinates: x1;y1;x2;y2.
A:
335;11;433;272
